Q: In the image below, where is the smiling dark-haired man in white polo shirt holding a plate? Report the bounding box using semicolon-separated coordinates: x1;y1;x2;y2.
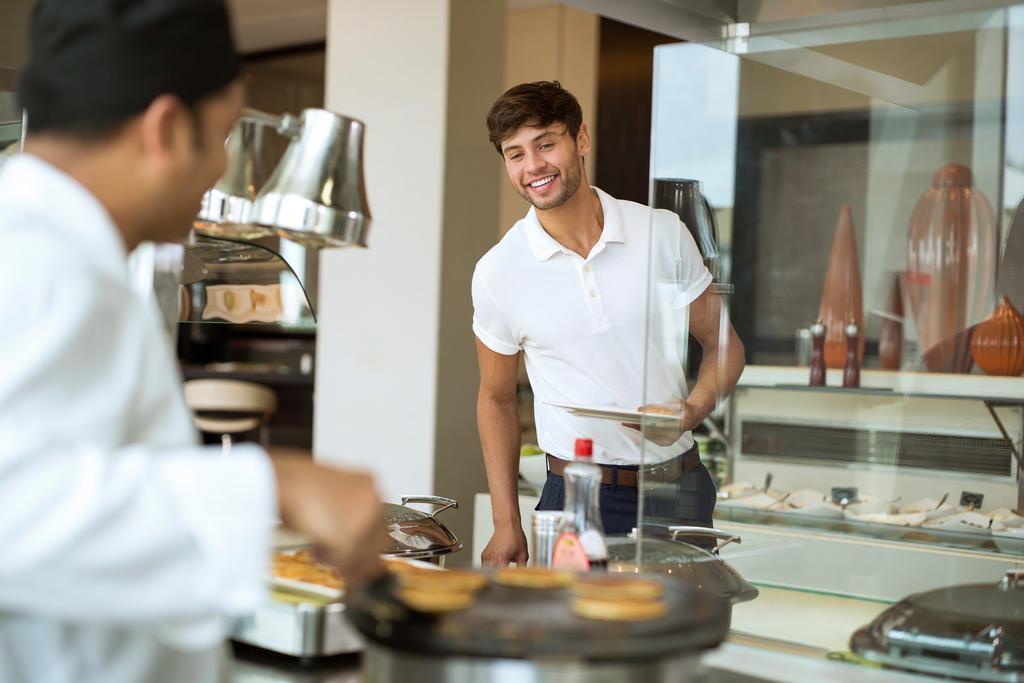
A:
473;81;743;565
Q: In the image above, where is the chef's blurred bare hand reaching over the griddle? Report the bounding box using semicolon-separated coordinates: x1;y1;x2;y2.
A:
270;452;386;584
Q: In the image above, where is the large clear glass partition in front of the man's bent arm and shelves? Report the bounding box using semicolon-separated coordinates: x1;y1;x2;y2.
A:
638;3;1024;651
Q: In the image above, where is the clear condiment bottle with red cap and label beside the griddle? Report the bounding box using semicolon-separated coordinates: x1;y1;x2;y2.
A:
552;438;608;571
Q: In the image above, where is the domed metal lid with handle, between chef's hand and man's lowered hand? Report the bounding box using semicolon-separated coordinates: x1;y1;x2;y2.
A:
383;496;462;559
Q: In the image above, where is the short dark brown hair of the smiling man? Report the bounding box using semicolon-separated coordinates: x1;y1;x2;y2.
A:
487;81;583;154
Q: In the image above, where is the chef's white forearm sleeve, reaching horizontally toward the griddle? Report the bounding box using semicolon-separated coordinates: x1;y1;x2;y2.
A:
0;438;274;624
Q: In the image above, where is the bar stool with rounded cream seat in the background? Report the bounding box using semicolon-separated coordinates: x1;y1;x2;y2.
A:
184;380;278;453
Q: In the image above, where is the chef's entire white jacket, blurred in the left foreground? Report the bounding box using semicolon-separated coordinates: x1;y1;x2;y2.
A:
0;156;275;683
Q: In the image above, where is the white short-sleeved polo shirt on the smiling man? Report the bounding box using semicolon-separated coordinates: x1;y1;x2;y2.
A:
473;187;712;465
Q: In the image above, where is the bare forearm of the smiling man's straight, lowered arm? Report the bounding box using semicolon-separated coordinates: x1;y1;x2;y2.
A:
476;395;520;527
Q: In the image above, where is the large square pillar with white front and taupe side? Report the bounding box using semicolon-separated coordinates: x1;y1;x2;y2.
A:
313;0;505;564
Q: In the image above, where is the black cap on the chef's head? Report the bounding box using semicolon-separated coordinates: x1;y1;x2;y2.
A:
18;0;239;132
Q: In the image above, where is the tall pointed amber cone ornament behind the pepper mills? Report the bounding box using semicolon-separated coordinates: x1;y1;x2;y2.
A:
818;204;864;368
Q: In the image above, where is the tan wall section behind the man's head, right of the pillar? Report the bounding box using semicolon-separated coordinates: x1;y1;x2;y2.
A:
497;5;600;234
